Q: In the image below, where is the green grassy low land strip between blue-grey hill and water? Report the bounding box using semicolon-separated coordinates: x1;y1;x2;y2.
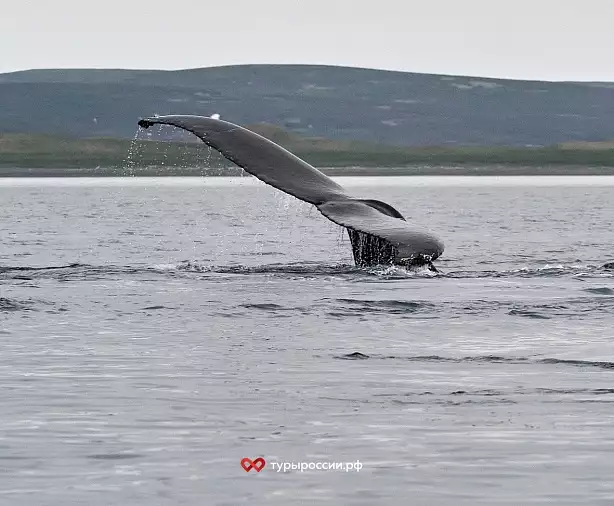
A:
0;125;614;176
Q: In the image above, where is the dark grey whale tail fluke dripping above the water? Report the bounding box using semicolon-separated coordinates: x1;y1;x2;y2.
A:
139;116;443;269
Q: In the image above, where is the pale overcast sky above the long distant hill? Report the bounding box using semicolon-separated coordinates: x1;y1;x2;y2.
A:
0;0;614;81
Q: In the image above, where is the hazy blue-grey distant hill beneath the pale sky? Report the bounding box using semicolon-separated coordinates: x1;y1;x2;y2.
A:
0;65;614;148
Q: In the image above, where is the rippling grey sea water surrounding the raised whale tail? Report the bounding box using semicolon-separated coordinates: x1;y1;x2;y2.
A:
0;177;614;506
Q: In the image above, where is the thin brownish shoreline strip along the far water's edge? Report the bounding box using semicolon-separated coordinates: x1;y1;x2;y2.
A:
0;165;614;178
